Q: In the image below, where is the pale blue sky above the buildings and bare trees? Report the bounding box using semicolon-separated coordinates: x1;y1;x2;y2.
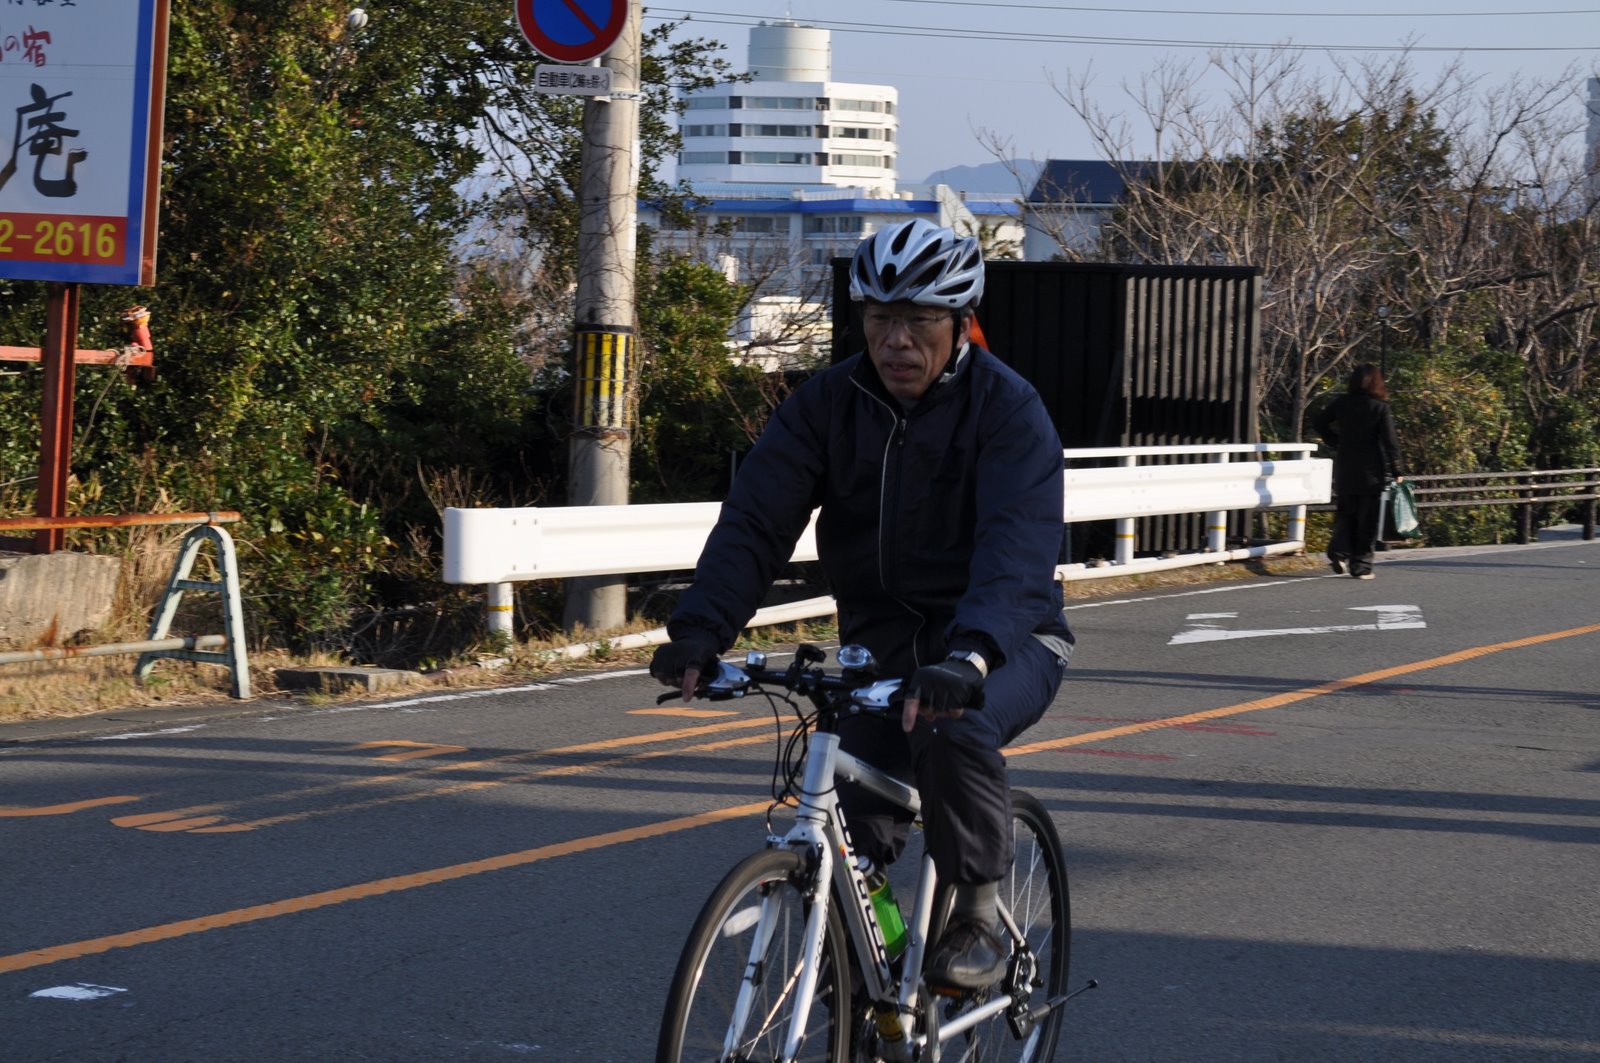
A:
645;0;1600;183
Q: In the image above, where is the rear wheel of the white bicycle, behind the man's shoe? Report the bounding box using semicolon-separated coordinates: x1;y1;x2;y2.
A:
928;791;1072;1063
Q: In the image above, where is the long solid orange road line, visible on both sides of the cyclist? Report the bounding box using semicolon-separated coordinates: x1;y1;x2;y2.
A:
0;624;1600;973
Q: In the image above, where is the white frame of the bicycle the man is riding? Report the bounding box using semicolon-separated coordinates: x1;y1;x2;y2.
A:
723;723;1022;1063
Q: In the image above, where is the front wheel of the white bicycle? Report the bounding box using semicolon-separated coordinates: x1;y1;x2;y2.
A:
656;848;850;1063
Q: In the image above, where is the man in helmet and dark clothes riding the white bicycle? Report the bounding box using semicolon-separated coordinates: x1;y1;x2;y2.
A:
650;219;1072;989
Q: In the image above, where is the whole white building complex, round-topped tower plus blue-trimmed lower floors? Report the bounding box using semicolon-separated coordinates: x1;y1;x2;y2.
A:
638;19;1022;368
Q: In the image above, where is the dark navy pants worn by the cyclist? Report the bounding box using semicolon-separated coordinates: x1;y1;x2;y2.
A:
838;639;1066;884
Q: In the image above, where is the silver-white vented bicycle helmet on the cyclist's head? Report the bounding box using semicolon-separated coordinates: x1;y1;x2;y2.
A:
850;218;984;311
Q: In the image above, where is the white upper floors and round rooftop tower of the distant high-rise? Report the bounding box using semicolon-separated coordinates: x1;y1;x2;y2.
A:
678;21;899;194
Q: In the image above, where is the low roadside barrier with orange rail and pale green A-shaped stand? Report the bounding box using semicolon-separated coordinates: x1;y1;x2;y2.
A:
0;511;250;698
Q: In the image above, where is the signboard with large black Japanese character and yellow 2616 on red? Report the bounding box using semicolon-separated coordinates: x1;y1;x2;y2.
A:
0;0;170;285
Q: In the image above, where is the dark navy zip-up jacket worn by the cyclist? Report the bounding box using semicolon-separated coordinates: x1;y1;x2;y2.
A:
667;344;1072;676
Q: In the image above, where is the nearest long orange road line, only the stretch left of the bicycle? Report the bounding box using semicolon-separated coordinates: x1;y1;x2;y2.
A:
0;800;768;975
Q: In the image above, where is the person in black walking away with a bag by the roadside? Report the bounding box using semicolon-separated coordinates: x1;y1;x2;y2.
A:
1312;362;1403;580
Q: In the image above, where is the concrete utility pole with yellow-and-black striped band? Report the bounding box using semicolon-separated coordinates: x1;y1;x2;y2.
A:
563;0;643;631
